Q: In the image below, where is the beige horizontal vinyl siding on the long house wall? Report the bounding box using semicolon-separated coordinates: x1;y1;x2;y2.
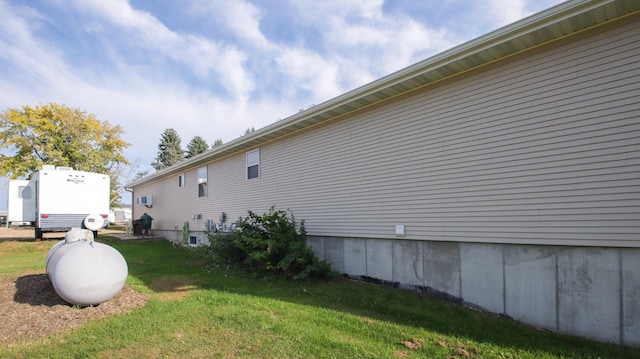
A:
136;16;640;247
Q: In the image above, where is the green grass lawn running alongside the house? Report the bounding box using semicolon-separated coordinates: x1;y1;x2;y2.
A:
0;237;640;358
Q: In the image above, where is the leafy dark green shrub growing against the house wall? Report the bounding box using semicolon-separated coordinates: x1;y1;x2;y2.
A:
209;207;335;279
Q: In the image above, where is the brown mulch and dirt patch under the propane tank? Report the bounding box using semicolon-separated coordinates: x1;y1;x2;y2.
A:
0;274;148;342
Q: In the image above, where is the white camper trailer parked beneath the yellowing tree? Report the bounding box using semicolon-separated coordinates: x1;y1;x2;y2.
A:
9;165;110;238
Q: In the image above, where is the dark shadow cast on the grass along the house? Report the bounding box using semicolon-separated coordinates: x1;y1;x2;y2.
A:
103;237;640;357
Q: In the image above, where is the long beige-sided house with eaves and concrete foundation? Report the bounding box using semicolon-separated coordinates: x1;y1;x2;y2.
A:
130;1;640;345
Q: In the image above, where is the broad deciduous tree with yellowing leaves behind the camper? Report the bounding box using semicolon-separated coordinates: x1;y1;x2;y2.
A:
0;103;129;208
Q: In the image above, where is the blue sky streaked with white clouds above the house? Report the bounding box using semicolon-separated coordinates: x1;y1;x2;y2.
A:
0;0;561;210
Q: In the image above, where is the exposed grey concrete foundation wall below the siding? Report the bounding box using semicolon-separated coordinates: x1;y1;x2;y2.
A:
309;237;640;346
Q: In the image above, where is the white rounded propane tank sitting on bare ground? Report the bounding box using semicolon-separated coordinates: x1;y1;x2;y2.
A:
46;228;128;306
